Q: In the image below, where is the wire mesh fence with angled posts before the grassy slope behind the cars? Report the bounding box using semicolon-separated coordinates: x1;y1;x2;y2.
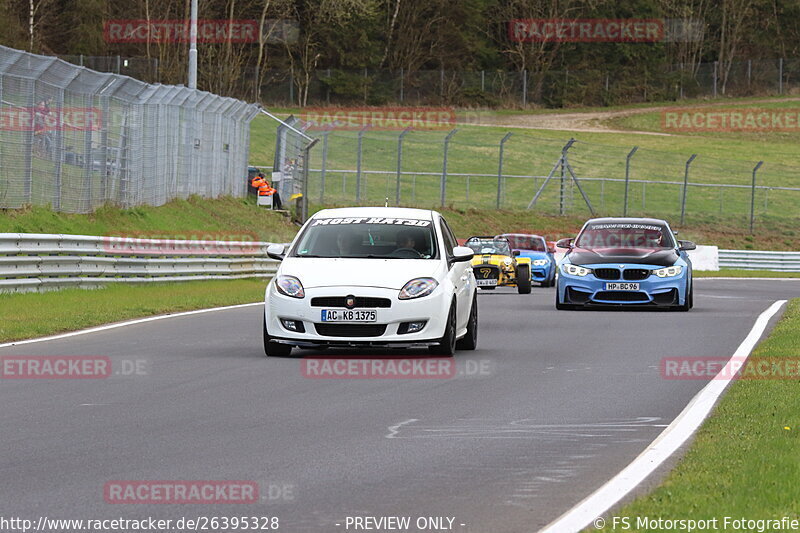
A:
290;123;800;227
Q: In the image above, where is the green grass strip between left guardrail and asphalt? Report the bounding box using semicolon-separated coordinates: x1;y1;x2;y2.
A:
0;279;267;342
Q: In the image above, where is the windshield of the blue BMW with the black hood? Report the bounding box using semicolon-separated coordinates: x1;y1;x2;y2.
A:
576;223;675;250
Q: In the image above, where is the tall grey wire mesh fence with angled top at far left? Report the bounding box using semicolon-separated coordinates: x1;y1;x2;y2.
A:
0;47;258;213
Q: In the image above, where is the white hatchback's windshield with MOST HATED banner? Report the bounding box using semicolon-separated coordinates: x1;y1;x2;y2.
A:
291;217;437;259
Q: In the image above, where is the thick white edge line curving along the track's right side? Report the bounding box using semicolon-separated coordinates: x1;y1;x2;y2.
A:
540;300;786;533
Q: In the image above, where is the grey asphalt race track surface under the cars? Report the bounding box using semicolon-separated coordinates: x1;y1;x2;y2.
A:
0;280;800;533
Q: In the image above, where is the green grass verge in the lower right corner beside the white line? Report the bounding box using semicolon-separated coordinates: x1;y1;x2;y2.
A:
587;300;800;531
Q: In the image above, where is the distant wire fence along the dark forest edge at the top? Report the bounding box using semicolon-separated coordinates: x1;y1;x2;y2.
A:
256;59;800;108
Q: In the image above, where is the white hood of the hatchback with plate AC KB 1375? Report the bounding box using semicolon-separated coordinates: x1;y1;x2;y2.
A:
280;257;444;290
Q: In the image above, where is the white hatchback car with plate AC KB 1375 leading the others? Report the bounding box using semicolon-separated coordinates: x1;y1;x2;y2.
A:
264;207;478;356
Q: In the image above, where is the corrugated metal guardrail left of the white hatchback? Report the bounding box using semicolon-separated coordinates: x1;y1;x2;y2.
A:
0;233;278;292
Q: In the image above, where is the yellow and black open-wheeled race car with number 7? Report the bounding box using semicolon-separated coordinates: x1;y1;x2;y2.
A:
465;236;531;294
